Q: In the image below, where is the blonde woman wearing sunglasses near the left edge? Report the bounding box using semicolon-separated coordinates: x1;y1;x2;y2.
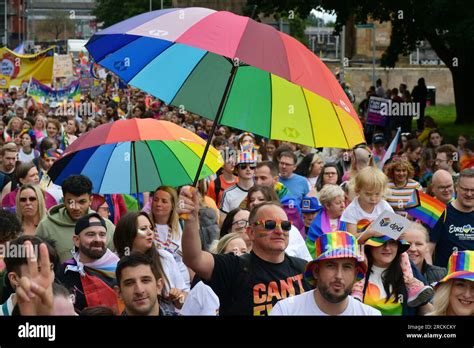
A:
16;184;46;236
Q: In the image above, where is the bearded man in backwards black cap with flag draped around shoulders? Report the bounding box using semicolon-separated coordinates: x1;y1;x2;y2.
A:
58;213;119;313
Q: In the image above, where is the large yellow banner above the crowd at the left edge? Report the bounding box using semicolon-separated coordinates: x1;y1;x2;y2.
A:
0;47;54;88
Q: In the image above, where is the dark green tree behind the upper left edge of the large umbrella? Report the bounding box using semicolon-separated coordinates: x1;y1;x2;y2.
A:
93;0;172;28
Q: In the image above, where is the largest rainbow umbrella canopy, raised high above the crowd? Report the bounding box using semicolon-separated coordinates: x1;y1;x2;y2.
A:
86;8;365;148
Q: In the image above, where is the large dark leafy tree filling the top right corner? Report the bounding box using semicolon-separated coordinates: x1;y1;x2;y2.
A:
244;0;474;124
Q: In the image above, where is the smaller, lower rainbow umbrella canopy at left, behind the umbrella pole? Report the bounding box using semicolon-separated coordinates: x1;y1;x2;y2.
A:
48;118;223;194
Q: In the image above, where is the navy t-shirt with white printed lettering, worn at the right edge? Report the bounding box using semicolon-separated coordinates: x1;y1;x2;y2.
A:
430;203;474;268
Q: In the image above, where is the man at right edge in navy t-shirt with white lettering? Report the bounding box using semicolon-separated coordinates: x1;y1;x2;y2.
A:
430;169;474;267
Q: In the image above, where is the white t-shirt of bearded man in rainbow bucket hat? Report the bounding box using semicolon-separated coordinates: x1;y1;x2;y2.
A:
270;290;382;315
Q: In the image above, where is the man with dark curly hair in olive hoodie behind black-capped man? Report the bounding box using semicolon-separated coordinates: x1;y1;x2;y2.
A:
36;175;115;262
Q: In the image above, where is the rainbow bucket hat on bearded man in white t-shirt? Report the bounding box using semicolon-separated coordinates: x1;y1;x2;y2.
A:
304;231;367;287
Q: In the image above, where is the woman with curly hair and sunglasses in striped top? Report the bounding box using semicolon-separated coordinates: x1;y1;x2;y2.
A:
385;158;423;216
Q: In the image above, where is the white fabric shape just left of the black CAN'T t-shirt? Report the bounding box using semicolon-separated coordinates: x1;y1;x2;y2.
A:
180;281;220;315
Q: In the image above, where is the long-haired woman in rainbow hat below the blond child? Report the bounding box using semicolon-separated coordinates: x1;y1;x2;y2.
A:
353;230;433;315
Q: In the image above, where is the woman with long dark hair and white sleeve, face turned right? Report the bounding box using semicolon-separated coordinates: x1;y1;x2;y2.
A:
114;212;189;310
